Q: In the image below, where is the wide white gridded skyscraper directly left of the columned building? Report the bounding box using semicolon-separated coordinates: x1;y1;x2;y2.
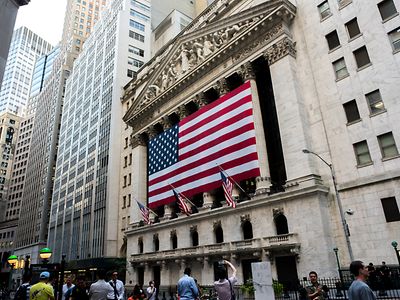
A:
48;0;206;265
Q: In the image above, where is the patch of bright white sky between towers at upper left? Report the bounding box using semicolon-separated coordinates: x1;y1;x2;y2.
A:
14;0;67;46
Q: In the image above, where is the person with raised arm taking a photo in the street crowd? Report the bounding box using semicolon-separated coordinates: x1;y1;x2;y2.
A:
214;260;237;300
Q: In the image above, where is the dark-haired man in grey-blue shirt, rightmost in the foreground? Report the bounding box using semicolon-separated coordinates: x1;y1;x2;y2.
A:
348;260;376;300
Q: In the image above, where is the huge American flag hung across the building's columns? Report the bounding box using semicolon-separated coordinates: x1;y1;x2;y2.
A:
148;82;260;208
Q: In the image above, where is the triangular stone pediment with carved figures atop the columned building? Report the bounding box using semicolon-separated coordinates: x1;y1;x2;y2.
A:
124;0;295;127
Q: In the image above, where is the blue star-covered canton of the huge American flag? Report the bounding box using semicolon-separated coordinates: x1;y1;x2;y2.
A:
148;125;179;175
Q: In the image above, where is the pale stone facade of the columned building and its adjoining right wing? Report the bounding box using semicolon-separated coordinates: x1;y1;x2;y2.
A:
123;0;400;288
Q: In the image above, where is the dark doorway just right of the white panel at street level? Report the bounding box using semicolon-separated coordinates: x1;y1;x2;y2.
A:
275;256;298;290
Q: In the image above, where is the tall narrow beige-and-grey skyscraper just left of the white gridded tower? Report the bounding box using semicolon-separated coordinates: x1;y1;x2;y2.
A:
14;0;106;262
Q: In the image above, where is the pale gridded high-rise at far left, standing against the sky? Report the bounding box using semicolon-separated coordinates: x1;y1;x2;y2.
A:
0;27;53;116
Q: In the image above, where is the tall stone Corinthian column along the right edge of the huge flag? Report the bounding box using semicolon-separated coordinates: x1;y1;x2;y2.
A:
239;62;271;194
